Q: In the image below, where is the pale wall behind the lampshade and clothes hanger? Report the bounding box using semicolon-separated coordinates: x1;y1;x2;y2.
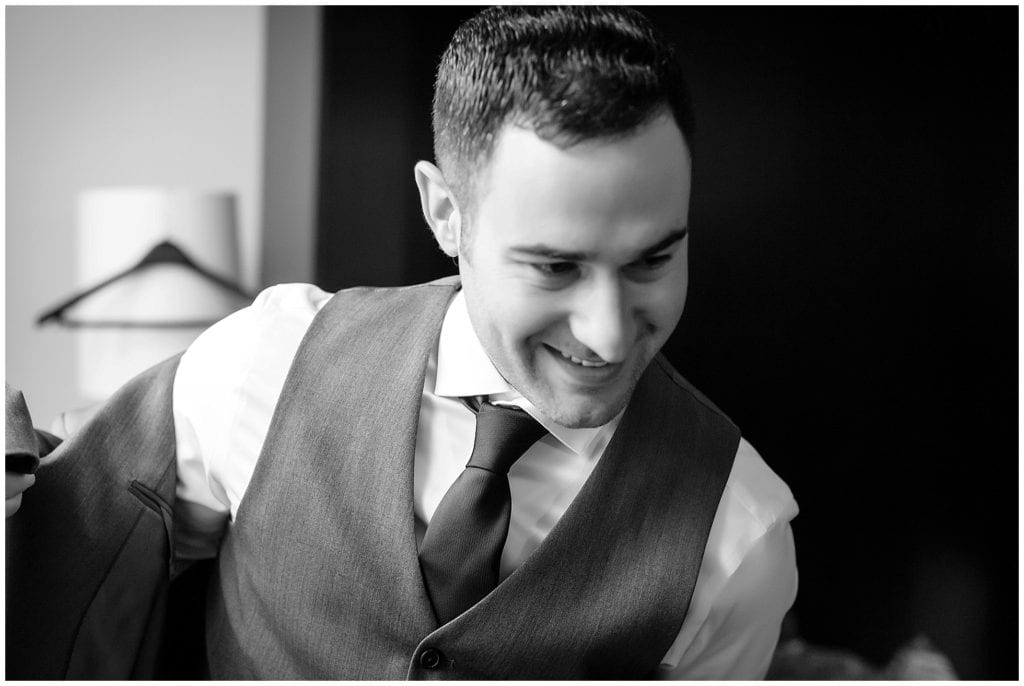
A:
5;6;266;426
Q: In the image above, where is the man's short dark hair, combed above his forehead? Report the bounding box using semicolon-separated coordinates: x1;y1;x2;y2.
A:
433;6;693;205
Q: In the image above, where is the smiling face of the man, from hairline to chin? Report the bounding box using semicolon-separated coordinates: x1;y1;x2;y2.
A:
460;116;690;428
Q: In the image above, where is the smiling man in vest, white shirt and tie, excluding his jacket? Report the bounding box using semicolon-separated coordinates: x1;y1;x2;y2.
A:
8;7;797;679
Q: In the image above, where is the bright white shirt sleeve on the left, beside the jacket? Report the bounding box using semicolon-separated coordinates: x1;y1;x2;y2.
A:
173;284;330;559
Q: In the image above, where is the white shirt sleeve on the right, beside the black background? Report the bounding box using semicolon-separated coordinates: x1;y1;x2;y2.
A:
657;440;798;680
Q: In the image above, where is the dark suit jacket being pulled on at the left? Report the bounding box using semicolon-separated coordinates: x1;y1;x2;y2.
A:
6;357;178;679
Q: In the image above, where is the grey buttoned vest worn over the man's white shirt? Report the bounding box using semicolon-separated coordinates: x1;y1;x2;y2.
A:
207;280;739;680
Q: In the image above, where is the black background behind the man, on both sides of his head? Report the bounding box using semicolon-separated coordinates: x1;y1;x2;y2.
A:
316;7;1018;679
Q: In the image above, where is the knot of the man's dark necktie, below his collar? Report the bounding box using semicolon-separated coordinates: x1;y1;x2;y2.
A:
466;402;547;474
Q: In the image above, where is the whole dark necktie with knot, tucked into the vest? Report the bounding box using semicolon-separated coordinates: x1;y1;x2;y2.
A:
420;402;546;624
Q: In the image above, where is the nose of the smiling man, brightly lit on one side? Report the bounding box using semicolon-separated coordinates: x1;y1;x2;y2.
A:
569;276;637;362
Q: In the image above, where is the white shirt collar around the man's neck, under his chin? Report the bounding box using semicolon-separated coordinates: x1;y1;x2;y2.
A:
434;290;622;457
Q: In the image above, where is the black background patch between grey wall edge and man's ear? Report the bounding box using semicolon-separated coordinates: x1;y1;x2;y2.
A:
316;6;466;290
